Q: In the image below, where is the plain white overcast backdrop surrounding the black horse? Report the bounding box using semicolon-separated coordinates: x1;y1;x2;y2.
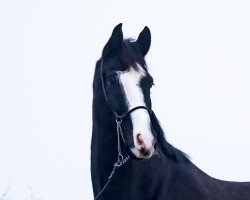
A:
0;0;250;200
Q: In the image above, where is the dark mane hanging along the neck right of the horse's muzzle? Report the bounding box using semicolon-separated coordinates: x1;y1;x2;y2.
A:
151;112;190;163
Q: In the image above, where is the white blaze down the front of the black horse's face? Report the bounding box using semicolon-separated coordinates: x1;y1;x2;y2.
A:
120;66;154;148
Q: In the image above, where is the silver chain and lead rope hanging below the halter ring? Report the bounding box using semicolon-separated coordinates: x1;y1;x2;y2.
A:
94;118;129;200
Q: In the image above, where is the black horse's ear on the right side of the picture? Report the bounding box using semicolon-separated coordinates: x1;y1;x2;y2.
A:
136;26;151;56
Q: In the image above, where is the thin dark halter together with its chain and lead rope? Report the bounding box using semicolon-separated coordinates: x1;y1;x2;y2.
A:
94;59;152;200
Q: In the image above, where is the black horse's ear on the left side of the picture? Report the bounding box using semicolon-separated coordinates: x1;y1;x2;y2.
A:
102;23;123;57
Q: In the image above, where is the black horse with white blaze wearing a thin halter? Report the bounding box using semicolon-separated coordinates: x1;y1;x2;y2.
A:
91;24;250;200
